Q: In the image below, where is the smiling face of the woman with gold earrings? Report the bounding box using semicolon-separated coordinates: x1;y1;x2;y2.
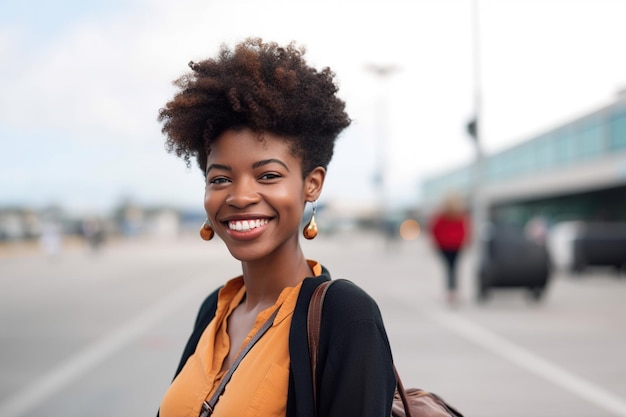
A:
204;129;325;261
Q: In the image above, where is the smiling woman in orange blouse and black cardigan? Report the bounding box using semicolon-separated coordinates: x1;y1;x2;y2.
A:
159;39;395;417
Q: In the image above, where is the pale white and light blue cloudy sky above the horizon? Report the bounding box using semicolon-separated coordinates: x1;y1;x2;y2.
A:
0;0;626;213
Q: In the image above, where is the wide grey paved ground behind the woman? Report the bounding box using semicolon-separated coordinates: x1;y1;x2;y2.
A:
0;233;626;417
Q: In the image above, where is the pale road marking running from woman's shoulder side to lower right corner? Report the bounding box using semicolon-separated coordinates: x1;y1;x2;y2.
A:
424;311;626;417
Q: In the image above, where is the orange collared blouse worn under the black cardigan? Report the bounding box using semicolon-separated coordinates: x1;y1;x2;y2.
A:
160;261;322;417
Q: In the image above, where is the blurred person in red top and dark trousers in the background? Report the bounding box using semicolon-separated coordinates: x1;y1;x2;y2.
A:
429;194;470;304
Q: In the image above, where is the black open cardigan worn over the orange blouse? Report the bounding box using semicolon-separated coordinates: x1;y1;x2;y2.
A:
157;268;396;417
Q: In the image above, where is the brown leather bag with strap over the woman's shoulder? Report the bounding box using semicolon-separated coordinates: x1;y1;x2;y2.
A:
307;281;463;417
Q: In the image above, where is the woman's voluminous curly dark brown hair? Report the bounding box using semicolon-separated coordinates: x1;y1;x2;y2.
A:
158;38;351;177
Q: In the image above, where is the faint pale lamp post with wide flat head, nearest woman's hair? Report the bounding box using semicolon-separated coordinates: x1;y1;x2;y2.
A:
365;64;399;236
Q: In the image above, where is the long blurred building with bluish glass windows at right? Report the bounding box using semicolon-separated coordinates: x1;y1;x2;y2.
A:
422;91;626;225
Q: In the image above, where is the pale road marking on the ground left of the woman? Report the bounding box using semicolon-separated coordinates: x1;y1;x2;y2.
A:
0;279;206;417
